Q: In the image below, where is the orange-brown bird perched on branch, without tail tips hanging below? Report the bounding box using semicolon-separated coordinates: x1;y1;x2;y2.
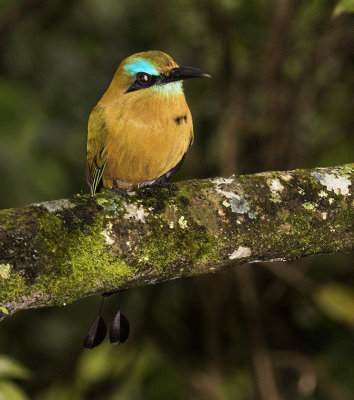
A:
86;50;210;195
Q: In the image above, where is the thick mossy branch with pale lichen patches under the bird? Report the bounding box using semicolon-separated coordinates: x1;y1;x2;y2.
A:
0;164;354;316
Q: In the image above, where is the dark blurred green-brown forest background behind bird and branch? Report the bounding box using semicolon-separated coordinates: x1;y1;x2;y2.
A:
0;0;354;400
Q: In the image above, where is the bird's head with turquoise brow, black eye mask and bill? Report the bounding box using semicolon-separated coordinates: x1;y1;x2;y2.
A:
105;50;210;95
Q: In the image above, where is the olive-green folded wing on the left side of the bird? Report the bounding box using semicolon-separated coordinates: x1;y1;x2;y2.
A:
86;106;108;195
